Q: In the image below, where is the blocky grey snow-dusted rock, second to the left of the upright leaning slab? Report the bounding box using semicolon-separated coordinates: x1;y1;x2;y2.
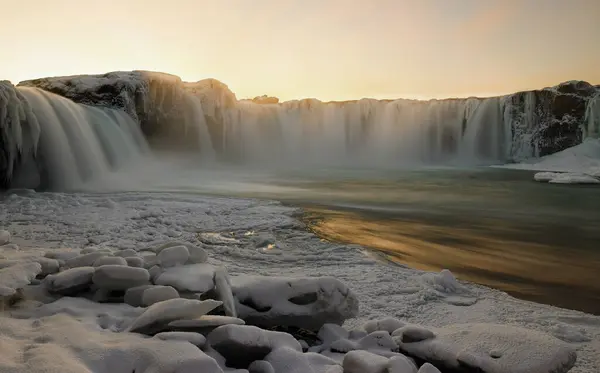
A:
92;265;150;290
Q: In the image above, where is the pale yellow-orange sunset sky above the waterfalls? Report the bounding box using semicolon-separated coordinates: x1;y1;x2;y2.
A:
0;0;600;100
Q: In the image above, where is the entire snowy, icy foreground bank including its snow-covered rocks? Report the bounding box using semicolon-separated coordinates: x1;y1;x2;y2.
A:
0;192;600;373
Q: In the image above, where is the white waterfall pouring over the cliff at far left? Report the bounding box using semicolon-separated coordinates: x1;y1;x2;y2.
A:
18;87;147;190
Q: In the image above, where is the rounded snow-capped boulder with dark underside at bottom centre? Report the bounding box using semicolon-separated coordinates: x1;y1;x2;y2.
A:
207;325;302;368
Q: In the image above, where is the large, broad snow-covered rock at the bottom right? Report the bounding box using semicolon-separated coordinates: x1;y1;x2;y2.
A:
394;324;577;373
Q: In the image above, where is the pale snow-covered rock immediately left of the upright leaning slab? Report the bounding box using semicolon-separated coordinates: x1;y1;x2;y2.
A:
154;264;215;293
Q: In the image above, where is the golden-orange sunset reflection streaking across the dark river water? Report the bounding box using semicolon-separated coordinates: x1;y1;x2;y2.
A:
305;206;600;314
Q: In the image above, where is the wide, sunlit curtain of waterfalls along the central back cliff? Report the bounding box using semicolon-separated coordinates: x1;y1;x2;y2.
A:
218;98;511;166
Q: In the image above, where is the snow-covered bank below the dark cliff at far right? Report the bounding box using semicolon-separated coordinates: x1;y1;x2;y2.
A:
497;138;600;184
